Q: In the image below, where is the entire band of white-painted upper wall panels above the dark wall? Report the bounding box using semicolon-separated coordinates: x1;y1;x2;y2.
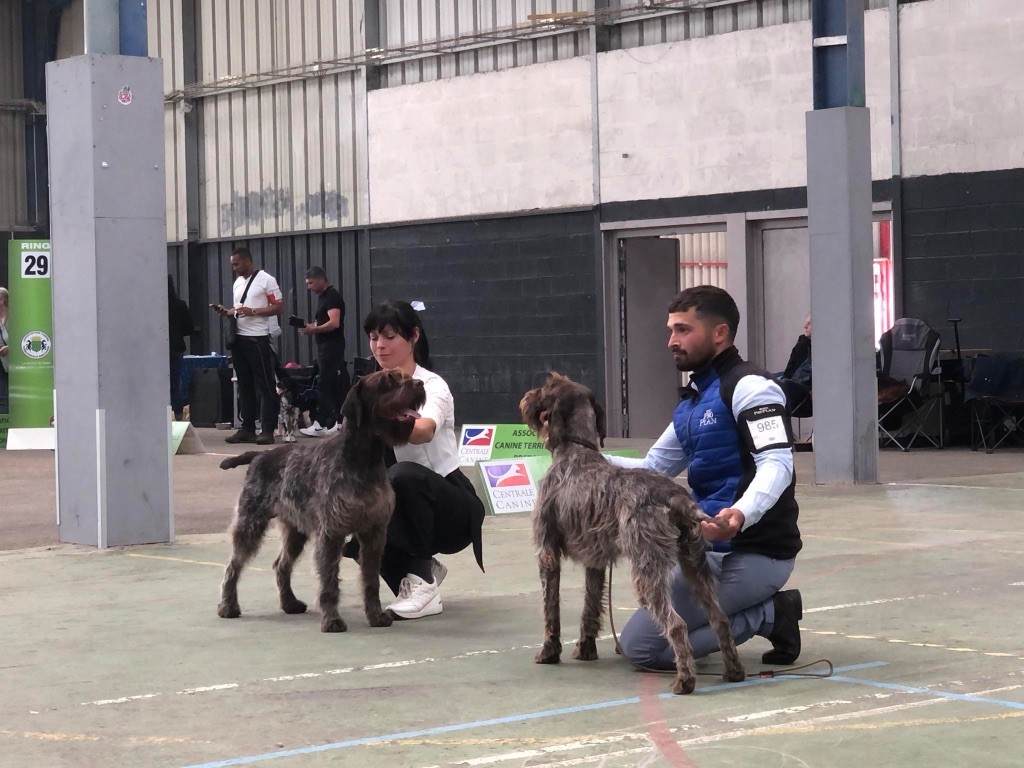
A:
370;0;1024;223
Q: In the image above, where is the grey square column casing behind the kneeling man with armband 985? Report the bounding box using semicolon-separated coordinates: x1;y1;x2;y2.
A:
807;106;879;483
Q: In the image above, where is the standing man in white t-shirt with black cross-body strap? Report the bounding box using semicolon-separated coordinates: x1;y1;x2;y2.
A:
213;248;284;445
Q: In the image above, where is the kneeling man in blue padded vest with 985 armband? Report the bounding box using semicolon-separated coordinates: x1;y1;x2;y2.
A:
608;286;803;669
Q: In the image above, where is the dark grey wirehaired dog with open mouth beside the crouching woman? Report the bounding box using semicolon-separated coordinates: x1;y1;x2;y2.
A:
217;371;426;632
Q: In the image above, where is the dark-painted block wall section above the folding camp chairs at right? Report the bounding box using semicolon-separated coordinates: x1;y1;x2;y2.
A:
902;169;1024;354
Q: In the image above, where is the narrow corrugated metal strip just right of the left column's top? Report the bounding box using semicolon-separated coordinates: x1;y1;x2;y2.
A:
147;0;187;243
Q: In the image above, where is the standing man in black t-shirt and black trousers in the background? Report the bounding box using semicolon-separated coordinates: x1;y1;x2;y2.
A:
299;266;348;437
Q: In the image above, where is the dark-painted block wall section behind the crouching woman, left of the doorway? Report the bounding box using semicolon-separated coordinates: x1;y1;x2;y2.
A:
370;212;604;423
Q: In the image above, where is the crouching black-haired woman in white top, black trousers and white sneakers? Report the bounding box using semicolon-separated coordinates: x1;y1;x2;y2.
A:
362;301;483;618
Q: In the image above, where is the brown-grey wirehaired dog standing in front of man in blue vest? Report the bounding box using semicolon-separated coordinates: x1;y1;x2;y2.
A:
519;373;745;693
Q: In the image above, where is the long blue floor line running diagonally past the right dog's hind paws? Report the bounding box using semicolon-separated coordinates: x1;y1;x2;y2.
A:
185;662;886;768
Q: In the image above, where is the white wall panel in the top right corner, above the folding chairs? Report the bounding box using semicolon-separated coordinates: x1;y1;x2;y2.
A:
900;0;1024;176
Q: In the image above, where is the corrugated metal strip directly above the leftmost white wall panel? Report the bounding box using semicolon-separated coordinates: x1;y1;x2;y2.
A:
379;0;593;86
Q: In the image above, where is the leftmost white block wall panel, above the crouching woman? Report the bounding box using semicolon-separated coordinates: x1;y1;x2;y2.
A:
369;58;593;223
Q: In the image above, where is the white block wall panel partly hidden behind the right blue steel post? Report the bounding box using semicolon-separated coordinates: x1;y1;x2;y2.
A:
598;10;892;202
